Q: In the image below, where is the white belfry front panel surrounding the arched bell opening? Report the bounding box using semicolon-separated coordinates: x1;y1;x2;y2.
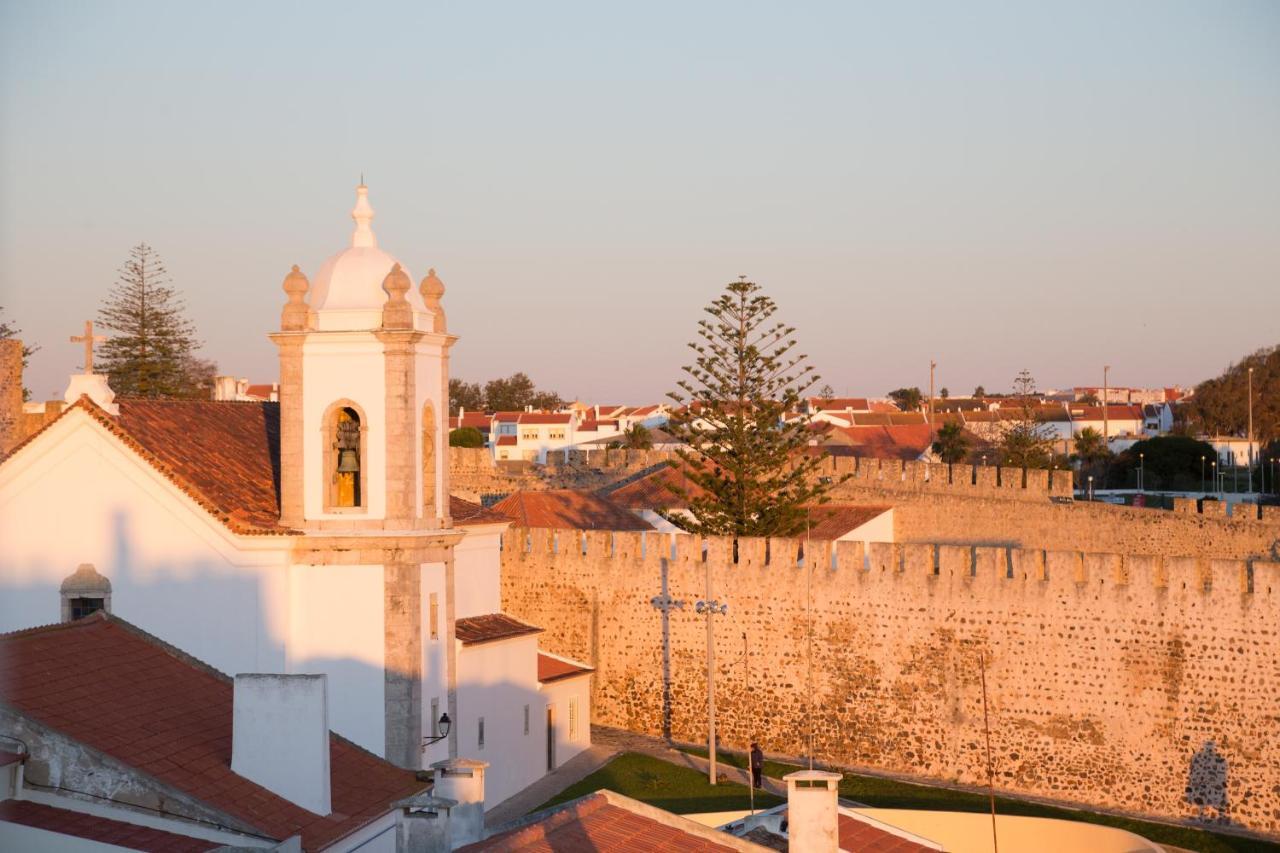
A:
302;332;387;520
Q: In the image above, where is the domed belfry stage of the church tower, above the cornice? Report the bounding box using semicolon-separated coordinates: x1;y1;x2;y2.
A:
271;184;457;530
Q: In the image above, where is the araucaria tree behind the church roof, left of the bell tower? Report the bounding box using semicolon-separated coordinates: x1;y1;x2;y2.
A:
97;243;204;397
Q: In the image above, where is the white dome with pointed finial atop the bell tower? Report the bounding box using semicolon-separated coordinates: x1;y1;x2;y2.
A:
310;186;426;329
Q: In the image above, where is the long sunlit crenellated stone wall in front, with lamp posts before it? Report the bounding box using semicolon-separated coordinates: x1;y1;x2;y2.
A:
502;525;1280;834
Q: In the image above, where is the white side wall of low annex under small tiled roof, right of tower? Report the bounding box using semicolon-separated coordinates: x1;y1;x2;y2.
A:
458;634;547;808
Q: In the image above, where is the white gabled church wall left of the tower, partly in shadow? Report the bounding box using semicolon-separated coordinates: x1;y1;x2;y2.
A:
0;411;289;672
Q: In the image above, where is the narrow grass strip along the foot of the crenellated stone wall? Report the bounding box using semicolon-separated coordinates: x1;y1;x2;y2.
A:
680;748;1280;853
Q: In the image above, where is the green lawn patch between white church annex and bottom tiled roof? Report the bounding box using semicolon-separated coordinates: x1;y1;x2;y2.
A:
534;752;782;815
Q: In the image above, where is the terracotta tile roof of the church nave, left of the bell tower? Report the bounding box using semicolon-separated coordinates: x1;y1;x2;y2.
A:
0;397;296;534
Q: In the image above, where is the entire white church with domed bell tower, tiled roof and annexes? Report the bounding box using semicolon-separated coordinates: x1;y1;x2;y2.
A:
0;186;590;804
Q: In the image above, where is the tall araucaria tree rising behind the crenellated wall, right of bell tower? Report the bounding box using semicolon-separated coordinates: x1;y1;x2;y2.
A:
667;280;833;537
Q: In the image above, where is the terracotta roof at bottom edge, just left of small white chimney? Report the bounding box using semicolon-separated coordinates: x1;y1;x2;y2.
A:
461;792;744;853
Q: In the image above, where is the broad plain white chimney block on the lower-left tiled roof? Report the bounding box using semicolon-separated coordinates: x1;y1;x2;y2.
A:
232;674;333;815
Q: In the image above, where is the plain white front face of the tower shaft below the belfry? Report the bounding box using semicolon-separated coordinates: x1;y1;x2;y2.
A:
287;565;387;756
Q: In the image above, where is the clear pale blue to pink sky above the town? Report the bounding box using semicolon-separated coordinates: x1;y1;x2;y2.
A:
0;0;1280;403
